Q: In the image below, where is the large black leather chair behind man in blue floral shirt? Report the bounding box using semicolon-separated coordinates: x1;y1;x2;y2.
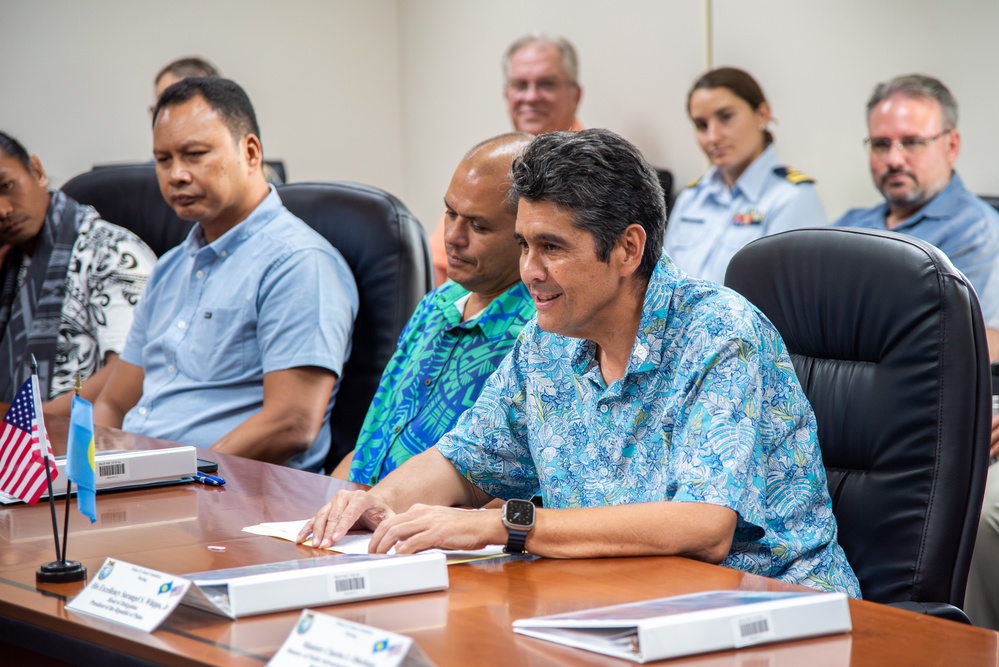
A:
725;227;991;622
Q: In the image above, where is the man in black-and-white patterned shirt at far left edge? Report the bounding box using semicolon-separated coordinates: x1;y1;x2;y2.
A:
0;132;156;415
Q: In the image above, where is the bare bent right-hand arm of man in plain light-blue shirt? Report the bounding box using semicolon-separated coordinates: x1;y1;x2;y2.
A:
212;366;336;463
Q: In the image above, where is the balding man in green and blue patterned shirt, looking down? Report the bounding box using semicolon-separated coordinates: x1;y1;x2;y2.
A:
333;133;534;484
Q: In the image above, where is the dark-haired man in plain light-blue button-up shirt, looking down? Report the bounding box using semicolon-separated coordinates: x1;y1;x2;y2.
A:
94;78;358;471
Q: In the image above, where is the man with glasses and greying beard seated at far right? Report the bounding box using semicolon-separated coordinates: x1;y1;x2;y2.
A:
834;74;999;360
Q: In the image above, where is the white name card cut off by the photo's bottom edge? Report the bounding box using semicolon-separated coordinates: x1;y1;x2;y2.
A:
267;609;433;667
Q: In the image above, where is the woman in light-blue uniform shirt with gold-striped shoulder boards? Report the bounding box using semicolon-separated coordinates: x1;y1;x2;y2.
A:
665;67;827;283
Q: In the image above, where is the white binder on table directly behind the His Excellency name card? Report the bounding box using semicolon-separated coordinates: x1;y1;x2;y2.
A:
183;553;448;619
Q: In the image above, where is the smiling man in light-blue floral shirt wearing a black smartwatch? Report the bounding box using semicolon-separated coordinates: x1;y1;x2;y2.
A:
299;130;860;597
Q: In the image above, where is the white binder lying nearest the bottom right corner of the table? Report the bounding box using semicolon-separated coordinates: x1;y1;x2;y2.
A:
513;591;852;663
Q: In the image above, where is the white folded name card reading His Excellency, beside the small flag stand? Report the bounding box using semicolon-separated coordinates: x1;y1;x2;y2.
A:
66;558;191;632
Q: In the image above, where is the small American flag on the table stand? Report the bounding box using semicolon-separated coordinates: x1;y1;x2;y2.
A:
0;378;58;505
